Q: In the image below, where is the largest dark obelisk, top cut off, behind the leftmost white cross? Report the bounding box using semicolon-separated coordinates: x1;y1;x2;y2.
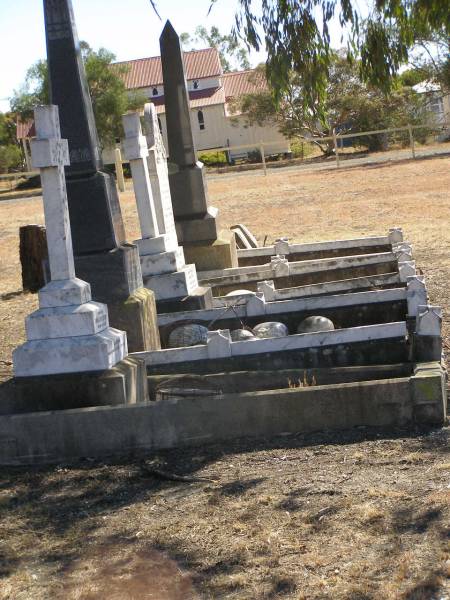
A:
40;0;159;351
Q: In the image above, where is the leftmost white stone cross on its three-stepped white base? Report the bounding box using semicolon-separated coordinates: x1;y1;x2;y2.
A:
13;106;127;377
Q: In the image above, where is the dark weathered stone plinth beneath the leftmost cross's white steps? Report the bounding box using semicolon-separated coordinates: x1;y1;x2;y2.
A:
0;357;148;415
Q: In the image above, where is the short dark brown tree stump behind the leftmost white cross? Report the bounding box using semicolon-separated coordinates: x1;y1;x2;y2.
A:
19;225;48;292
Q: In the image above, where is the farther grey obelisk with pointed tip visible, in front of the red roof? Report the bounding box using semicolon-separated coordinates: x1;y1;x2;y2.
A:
159;21;237;271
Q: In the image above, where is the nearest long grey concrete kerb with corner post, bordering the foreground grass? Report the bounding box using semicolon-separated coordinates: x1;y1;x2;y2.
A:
0;363;445;465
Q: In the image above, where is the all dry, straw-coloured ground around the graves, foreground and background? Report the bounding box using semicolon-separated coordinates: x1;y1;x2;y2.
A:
0;158;450;600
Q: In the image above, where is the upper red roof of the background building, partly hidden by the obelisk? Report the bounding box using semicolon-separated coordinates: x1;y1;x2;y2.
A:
112;48;222;90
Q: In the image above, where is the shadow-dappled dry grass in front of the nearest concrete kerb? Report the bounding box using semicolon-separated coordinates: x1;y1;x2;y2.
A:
0;430;450;600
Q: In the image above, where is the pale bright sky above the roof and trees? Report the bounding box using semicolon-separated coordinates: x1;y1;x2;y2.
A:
0;0;348;112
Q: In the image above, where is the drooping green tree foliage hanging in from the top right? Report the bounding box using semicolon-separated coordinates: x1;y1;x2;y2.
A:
230;0;450;110
